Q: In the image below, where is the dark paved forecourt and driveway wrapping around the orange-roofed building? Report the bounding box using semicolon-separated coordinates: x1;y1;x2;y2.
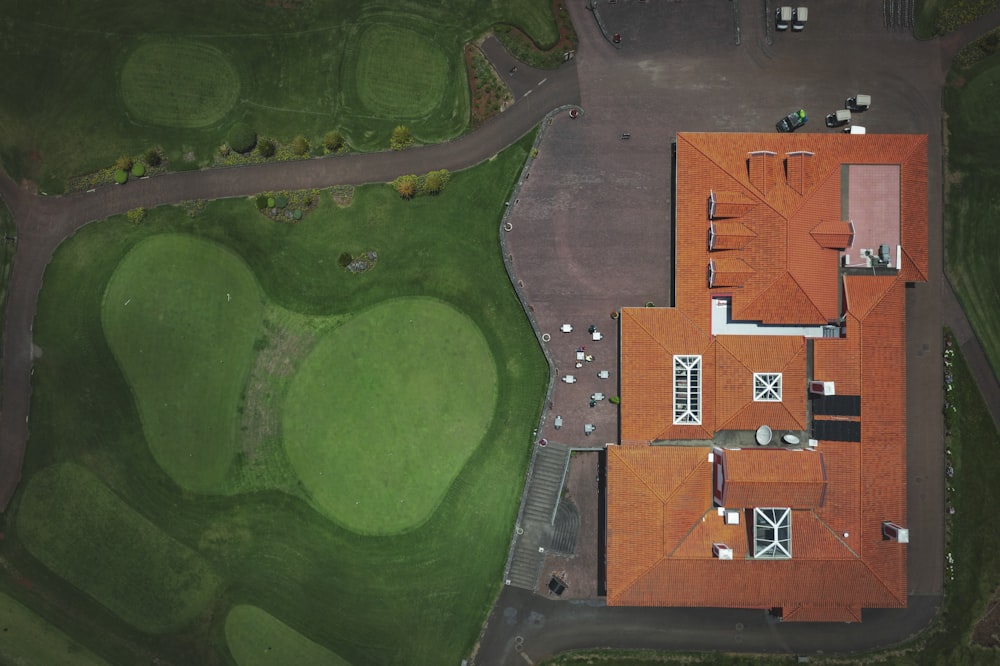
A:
477;0;947;664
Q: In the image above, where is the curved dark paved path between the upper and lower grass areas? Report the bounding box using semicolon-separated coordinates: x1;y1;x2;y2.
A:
0;40;580;511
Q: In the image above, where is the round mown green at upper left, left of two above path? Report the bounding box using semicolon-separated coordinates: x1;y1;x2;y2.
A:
121;40;240;127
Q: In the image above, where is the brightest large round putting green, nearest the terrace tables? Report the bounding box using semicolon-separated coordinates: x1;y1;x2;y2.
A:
283;298;497;534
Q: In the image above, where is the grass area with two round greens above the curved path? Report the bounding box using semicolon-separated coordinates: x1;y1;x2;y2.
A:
0;0;557;193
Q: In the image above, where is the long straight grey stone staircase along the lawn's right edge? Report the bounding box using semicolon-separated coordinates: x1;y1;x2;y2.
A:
505;442;570;590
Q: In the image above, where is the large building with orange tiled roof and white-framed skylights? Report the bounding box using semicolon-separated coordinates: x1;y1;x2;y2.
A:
607;133;928;622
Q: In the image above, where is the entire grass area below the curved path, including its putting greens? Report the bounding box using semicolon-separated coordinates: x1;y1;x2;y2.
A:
0;132;548;666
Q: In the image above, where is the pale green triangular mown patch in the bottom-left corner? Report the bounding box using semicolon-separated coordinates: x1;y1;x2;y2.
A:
0;593;108;666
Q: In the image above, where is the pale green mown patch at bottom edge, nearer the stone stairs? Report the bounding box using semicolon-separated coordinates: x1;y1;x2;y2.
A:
226;605;350;666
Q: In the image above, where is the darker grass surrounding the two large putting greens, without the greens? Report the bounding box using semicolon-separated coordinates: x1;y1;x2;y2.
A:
0;136;548;666
